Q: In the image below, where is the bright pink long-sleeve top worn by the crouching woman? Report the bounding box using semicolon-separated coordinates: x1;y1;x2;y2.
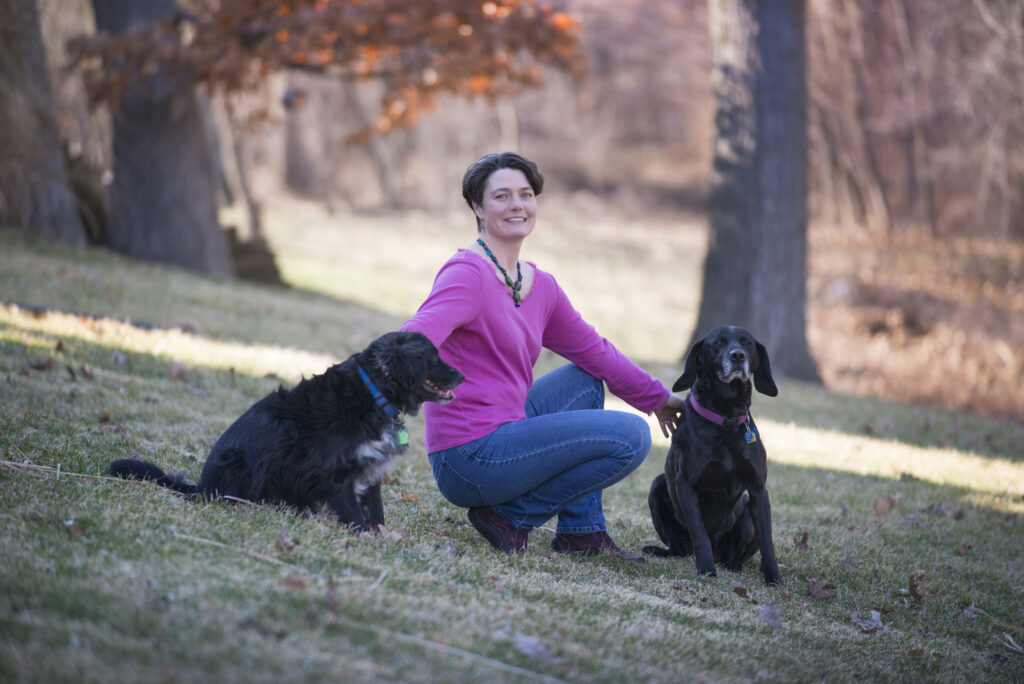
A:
401;250;669;453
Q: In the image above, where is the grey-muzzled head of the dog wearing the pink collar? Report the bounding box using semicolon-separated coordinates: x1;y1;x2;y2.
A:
672;326;778;396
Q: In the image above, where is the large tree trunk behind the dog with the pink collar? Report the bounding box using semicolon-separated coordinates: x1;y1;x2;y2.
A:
694;0;818;381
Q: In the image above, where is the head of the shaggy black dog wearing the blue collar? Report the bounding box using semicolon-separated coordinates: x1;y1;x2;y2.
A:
359;333;464;416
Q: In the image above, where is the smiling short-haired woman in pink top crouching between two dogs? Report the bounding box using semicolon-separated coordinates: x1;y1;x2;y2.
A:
402;153;682;562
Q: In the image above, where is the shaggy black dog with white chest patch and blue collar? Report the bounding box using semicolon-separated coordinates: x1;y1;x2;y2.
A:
111;333;463;530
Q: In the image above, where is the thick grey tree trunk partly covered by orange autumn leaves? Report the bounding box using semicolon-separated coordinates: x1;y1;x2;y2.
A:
92;0;231;275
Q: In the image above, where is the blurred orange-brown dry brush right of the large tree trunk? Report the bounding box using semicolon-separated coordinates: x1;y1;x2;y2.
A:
808;228;1024;421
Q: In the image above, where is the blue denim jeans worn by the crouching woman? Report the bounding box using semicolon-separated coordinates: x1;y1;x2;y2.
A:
430;364;650;533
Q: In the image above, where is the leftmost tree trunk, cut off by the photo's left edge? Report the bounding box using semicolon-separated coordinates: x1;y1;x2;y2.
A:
0;0;85;245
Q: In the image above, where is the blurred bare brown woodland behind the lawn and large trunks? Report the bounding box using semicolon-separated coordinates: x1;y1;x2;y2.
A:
0;0;1024;420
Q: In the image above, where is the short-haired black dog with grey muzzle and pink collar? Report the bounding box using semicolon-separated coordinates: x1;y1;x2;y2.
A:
644;326;781;585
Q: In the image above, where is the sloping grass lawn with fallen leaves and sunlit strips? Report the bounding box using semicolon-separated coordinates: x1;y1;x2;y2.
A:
0;206;1024;683
